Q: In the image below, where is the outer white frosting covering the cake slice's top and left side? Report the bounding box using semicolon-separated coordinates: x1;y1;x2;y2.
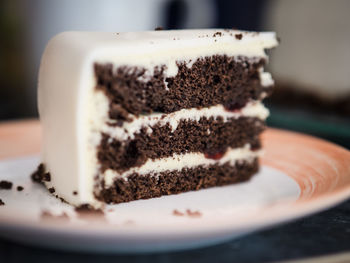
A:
38;29;277;208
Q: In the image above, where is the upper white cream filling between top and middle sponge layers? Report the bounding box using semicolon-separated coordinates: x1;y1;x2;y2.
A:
91;91;269;141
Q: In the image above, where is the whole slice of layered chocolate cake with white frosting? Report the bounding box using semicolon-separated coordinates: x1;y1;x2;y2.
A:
36;29;277;207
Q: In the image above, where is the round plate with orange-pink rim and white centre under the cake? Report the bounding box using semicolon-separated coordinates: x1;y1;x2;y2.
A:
0;121;350;252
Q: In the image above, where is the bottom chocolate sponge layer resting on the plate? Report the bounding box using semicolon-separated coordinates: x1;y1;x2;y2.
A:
96;159;258;203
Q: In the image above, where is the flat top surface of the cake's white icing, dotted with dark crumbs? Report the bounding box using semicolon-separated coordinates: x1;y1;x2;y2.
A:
51;29;277;53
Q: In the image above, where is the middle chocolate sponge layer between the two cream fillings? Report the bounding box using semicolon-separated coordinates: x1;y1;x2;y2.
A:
97;117;264;172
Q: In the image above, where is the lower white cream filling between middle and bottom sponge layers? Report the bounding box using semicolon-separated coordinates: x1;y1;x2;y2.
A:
103;144;261;187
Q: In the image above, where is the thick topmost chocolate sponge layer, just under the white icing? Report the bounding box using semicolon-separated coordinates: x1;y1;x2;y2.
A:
94;55;272;121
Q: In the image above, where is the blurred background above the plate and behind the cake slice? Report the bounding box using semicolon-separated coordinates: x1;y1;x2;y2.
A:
0;0;350;147
